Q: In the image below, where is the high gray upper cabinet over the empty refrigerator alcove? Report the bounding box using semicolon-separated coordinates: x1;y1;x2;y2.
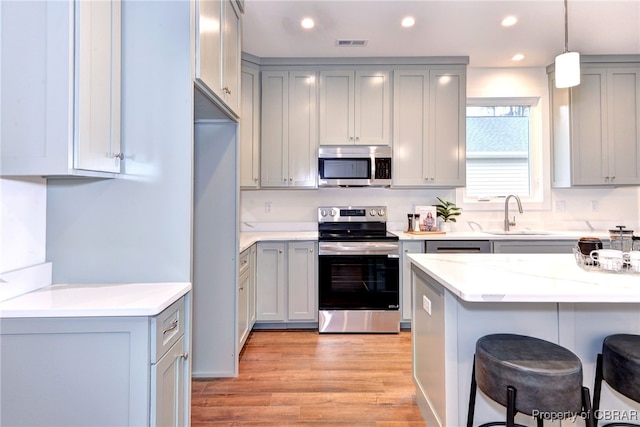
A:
195;0;241;117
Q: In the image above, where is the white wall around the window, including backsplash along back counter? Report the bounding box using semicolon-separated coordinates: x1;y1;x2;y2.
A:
241;68;640;232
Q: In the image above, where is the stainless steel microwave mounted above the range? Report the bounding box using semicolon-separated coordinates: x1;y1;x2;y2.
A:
318;145;391;187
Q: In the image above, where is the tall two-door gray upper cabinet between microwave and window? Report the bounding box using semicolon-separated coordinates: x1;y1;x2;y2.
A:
392;68;466;187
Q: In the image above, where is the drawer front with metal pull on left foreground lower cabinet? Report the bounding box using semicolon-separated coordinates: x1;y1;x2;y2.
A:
151;297;186;363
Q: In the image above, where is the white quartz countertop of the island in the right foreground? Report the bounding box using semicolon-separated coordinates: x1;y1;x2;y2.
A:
408;254;640;303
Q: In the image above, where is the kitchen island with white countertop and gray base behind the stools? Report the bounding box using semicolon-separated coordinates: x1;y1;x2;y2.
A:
409;254;640;427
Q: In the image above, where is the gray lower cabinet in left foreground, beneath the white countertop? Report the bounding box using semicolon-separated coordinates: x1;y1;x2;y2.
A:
0;294;191;427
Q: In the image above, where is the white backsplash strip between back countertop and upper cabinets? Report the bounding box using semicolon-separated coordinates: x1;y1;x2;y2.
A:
240;187;640;234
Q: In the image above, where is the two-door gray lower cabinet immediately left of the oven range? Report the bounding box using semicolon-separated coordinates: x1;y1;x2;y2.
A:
256;241;318;323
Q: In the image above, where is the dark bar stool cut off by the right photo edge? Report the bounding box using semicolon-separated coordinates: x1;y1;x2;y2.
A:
593;334;640;426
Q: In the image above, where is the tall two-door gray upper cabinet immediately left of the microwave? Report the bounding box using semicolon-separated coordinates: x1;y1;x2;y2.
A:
260;71;318;188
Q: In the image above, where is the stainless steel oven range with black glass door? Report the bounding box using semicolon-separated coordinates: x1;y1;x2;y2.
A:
318;206;400;333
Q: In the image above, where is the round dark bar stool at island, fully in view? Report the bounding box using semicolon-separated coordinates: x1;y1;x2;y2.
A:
467;334;593;427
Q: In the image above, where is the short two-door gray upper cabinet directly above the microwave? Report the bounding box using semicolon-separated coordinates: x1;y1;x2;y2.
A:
320;68;391;145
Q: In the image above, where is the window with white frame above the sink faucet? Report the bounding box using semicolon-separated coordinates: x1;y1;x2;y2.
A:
460;98;548;209
